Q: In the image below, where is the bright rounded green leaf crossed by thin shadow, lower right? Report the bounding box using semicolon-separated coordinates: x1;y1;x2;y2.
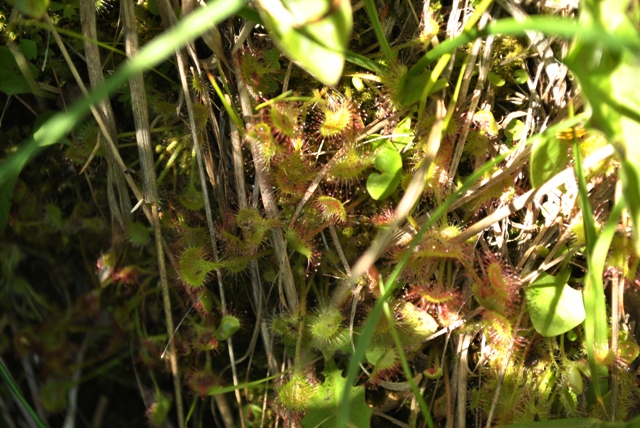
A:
525;270;585;337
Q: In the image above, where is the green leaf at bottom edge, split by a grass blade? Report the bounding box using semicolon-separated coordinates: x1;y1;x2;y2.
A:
302;359;371;428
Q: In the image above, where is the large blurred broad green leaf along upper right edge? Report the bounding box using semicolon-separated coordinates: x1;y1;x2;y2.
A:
566;0;640;254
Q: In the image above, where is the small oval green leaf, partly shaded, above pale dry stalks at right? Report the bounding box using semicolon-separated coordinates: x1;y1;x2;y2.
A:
530;138;569;188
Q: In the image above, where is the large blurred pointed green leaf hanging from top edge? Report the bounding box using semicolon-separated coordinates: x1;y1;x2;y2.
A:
259;0;353;86
